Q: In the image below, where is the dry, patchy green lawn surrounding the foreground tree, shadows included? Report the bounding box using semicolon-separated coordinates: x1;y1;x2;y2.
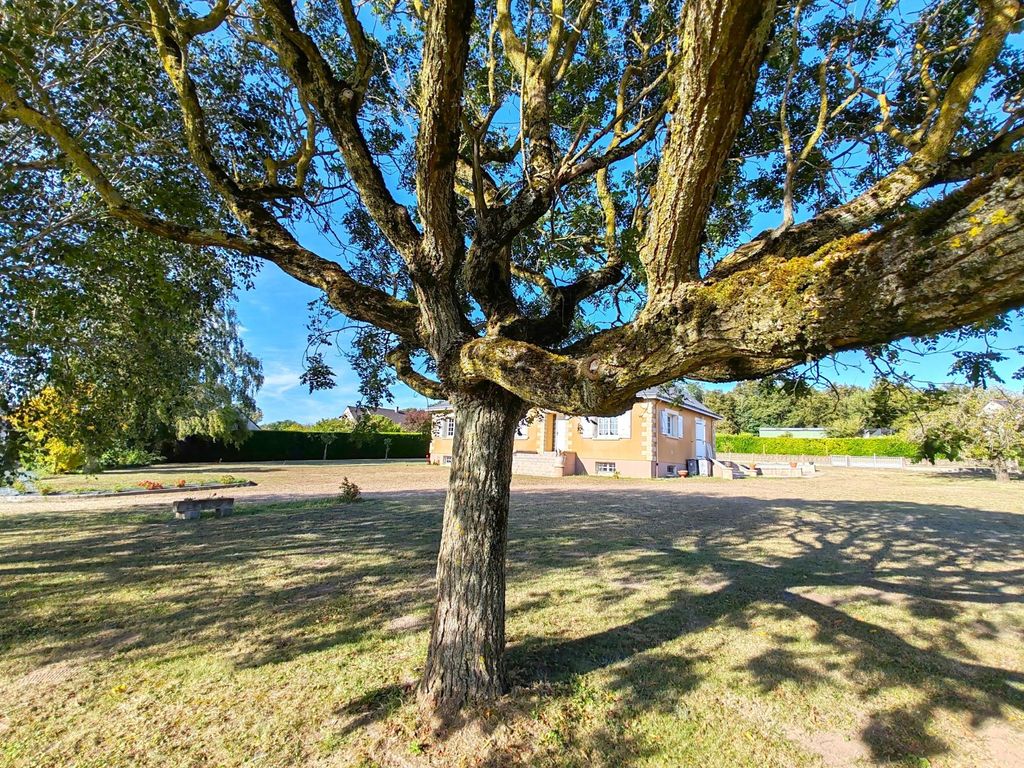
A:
0;464;1024;768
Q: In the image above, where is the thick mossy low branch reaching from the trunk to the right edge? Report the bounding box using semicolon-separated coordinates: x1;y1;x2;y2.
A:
462;156;1024;414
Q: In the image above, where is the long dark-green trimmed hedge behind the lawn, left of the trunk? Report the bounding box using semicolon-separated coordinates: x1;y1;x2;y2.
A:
165;429;430;463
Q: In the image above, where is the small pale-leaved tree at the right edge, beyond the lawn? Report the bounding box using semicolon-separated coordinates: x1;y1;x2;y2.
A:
913;390;1024;481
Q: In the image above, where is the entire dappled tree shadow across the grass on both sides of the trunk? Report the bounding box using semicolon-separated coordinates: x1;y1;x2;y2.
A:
0;484;1024;765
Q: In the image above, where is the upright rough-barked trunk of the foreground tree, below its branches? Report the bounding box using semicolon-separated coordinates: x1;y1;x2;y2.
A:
419;385;524;728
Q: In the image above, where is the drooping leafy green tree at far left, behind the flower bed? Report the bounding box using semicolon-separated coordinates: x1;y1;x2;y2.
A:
0;219;262;471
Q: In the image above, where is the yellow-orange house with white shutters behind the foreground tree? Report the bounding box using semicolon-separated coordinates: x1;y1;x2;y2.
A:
428;389;722;477
